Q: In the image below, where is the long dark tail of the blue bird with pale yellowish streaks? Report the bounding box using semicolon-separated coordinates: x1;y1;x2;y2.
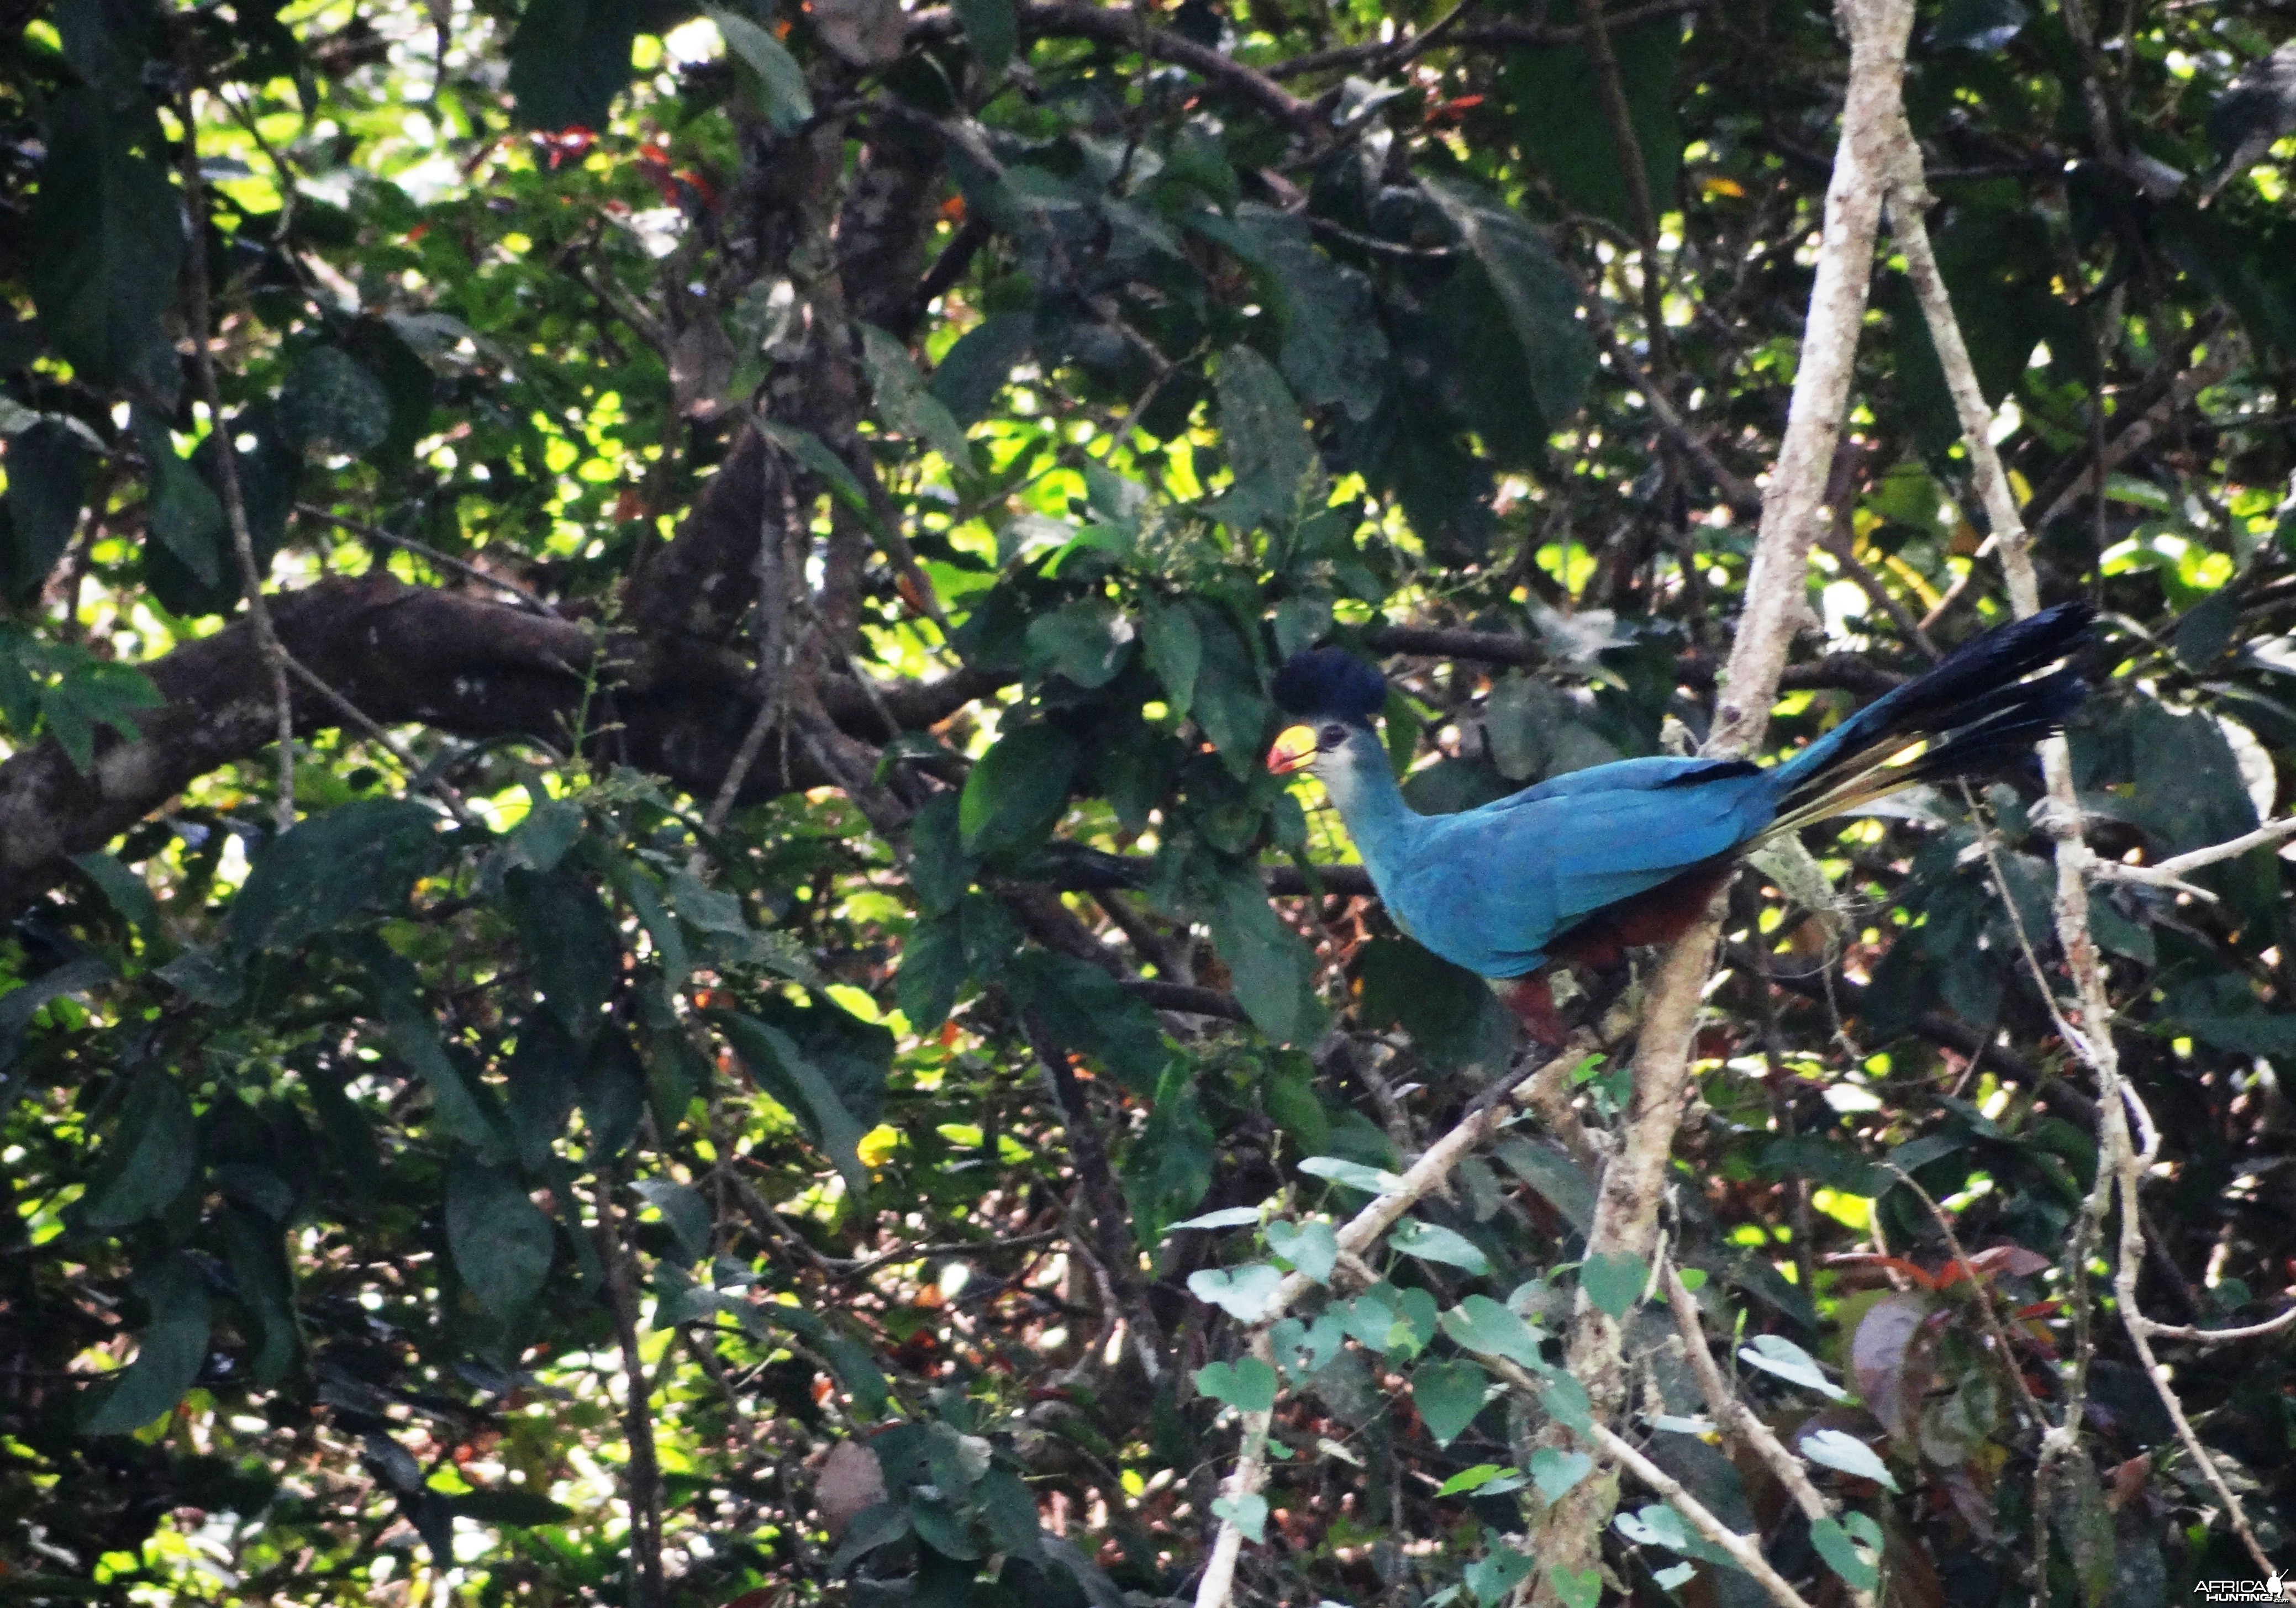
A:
1763;602;2096;836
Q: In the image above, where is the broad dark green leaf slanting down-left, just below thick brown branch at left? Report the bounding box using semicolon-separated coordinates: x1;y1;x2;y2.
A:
225;799;445;956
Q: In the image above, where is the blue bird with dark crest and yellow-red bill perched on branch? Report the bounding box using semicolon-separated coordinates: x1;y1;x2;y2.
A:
1267;602;2094;1045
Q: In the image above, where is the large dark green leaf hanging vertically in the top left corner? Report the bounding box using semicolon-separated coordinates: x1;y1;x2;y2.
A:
20;87;183;383
